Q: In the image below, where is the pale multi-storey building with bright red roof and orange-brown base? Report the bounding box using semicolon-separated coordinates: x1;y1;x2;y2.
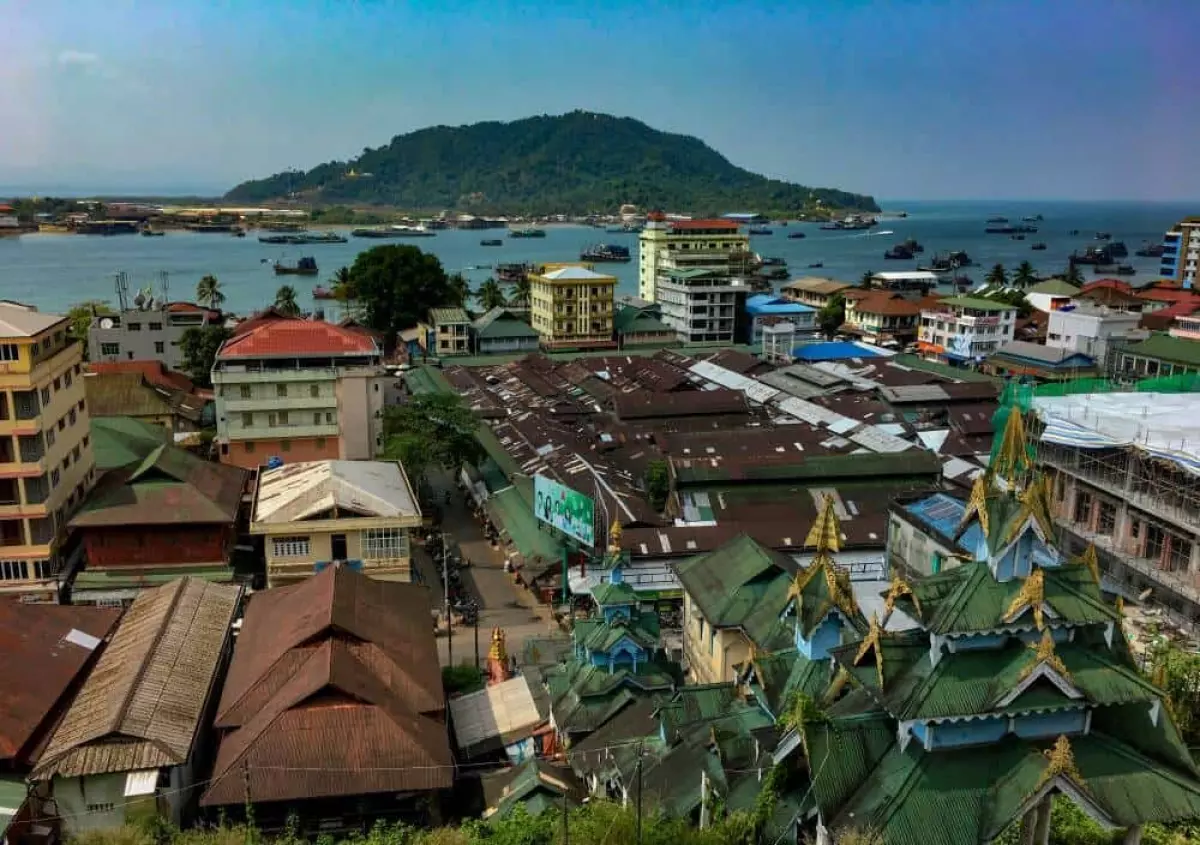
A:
212;316;391;468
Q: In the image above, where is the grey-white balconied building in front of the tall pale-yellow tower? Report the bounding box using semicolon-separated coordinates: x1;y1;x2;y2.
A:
655;266;750;343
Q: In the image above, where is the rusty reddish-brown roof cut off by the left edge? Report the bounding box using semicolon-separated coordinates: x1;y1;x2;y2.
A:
0;601;121;767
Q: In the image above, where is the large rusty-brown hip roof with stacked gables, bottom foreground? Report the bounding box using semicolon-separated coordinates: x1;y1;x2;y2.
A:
202;568;454;805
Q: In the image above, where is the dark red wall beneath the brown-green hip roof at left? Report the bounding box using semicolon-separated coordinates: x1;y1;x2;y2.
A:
83;525;234;569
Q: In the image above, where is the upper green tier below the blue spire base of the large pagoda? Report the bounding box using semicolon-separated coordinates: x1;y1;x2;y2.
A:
896;562;1121;635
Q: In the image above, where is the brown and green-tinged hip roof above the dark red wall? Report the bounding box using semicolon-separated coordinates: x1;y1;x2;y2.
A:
70;444;248;528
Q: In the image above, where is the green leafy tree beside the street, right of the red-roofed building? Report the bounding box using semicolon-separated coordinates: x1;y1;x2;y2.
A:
383;394;485;481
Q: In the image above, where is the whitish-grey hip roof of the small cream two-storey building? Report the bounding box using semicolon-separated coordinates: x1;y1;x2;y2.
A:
252;461;421;525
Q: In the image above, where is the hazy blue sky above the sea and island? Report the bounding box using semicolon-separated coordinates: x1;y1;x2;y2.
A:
0;0;1200;200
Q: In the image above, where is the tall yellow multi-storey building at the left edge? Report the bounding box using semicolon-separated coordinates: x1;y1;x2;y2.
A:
0;301;95;601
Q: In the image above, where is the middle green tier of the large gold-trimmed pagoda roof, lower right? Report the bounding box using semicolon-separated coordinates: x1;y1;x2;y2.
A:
833;631;1162;720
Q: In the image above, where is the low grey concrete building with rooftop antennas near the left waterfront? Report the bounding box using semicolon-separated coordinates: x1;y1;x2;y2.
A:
88;303;221;370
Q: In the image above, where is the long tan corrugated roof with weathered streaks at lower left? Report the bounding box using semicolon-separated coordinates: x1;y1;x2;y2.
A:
32;579;241;780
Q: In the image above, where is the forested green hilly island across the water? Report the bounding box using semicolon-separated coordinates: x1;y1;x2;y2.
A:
224;112;880;217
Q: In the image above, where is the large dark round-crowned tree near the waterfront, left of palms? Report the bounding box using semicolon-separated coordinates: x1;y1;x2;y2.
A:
348;244;455;350
